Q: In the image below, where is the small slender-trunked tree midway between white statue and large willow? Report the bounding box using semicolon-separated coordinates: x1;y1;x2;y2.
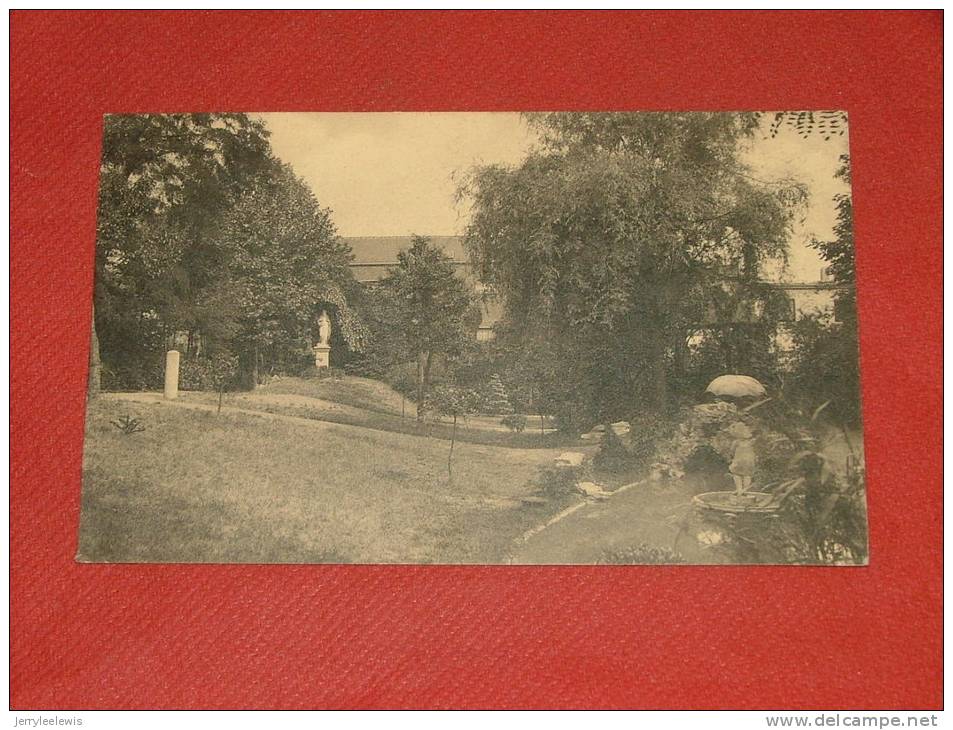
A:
382;235;478;421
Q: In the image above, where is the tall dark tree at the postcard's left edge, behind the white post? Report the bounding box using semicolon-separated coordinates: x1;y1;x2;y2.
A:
90;114;270;389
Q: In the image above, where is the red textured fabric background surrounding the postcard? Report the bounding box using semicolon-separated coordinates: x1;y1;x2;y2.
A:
11;11;942;709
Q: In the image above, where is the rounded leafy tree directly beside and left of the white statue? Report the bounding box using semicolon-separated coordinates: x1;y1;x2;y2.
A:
205;161;363;385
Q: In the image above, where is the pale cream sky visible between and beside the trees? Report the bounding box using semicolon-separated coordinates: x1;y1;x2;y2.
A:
258;112;847;281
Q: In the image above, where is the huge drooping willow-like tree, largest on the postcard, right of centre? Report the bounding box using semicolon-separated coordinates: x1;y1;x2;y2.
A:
461;113;804;421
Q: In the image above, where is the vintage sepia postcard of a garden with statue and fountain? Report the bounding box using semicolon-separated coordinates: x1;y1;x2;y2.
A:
77;111;868;565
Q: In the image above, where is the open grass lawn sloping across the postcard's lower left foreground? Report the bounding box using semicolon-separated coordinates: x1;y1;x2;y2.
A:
78;398;566;563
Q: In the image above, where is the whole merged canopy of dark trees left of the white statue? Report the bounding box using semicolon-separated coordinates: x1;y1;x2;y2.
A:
95;114;362;388
